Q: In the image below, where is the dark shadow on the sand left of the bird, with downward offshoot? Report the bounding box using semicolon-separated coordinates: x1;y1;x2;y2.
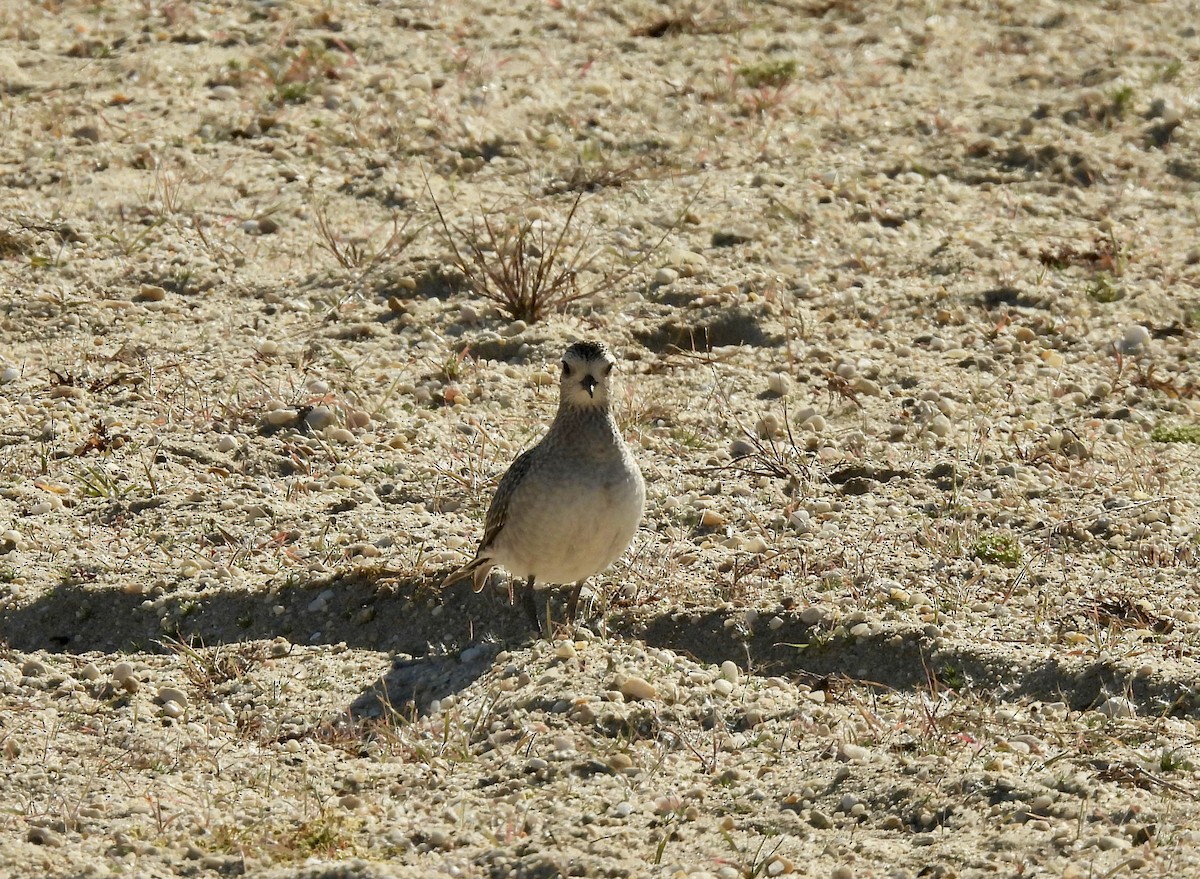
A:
0;569;544;717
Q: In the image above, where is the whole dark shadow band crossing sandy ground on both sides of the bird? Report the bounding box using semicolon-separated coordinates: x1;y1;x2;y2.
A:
0;569;1200;717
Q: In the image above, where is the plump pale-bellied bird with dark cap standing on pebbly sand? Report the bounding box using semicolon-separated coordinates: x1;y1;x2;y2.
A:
442;341;646;636
